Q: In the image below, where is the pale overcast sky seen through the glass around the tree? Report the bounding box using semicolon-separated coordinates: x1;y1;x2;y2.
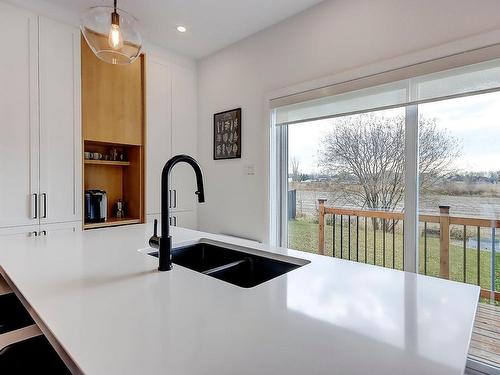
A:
288;92;500;173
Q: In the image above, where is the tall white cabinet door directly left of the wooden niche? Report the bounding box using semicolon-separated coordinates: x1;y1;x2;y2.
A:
39;17;82;224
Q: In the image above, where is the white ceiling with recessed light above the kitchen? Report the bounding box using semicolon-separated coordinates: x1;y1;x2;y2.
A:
43;0;322;59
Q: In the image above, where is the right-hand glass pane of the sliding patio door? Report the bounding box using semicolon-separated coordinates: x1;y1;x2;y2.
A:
419;92;500;367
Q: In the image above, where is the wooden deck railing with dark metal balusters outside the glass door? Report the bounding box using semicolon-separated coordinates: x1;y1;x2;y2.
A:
318;199;500;301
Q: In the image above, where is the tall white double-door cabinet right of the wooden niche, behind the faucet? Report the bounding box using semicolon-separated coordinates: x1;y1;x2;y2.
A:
146;55;197;223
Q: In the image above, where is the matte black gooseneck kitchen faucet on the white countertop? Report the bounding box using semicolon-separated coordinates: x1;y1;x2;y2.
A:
149;155;205;271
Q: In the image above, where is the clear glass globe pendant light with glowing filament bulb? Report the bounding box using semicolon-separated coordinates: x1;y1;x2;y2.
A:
80;0;142;65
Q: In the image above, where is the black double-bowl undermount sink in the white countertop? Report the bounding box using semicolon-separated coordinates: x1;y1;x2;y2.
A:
148;242;309;288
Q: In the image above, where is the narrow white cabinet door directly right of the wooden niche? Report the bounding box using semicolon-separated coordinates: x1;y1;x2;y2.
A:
146;57;172;215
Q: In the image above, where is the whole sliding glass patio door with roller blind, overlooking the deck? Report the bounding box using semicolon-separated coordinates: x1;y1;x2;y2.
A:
271;52;500;371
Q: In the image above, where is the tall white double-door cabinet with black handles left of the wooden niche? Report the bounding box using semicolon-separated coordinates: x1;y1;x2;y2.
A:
0;2;82;231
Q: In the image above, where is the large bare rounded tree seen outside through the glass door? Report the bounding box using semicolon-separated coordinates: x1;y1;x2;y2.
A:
318;113;460;222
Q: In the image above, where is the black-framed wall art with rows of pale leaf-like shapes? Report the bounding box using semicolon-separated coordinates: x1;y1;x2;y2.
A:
214;108;241;160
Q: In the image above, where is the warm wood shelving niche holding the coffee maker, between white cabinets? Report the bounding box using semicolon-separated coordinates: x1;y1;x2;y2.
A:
81;38;145;229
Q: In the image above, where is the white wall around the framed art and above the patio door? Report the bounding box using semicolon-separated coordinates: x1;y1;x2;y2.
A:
198;0;500;241
